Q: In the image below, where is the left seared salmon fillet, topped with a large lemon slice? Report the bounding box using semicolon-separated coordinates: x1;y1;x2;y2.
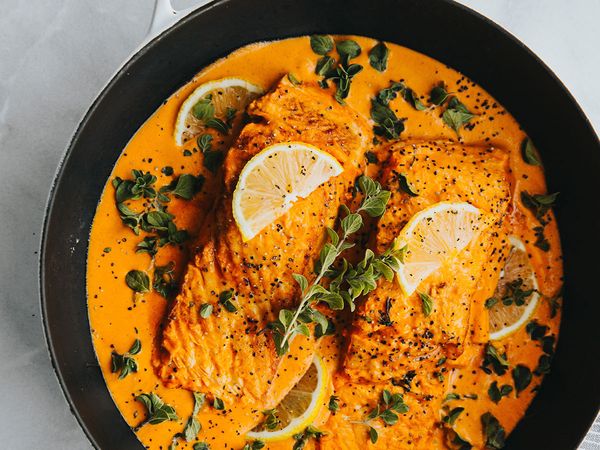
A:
156;76;369;426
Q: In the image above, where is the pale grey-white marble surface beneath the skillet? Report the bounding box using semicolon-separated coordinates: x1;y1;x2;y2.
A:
0;0;600;450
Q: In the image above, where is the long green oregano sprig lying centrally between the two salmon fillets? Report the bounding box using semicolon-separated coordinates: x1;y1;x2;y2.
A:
269;176;402;355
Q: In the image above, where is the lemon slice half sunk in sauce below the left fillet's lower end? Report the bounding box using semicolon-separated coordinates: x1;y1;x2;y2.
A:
246;355;329;442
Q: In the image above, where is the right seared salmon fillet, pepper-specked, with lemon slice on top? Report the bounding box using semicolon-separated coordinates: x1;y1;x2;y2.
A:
321;142;510;450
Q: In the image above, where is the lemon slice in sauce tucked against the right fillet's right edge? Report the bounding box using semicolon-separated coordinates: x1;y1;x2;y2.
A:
489;236;540;340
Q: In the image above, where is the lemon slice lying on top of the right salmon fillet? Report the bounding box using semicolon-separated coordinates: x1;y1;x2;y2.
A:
396;202;484;295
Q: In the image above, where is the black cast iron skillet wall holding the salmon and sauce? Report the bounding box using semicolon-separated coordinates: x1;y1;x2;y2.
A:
41;0;600;449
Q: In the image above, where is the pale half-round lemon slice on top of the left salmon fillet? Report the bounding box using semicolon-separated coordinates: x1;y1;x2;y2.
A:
233;142;344;241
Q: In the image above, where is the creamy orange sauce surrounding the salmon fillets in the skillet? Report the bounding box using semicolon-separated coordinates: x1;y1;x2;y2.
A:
87;36;562;449
